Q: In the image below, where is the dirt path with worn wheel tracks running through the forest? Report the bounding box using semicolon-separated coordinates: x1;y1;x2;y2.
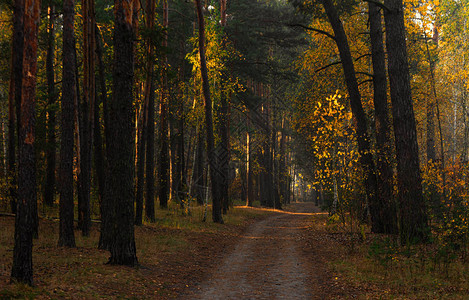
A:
188;203;330;299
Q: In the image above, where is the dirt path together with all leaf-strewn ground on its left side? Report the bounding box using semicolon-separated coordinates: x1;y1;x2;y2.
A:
0;203;353;299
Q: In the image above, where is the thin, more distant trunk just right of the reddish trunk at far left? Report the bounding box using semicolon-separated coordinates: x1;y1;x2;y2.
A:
44;3;56;206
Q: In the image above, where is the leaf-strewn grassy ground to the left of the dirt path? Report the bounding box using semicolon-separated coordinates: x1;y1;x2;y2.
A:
0;203;270;299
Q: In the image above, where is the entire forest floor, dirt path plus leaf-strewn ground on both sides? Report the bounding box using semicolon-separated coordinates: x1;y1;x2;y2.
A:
0;203;469;300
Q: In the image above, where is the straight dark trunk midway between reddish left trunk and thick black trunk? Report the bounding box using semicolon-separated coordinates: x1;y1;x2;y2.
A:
59;0;77;247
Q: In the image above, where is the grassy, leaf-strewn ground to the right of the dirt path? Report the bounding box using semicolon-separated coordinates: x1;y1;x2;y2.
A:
315;216;469;299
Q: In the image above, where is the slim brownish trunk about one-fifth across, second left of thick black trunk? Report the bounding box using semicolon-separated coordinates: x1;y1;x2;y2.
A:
78;0;96;236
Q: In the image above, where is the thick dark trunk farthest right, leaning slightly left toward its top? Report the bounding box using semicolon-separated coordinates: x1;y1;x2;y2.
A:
384;0;430;243
